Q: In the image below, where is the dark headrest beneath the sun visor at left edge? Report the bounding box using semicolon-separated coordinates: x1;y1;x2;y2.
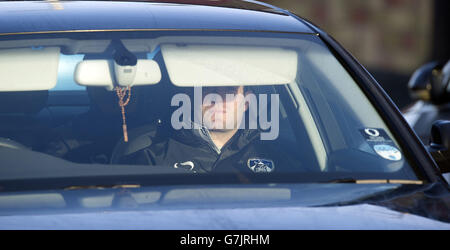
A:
0;90;48;114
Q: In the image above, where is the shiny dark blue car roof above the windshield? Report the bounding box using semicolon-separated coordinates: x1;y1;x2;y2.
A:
0;0;315;35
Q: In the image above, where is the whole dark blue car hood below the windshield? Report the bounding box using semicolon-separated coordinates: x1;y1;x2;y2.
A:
0;183;450;230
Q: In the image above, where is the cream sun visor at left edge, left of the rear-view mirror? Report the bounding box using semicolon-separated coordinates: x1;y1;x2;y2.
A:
0;47;60;92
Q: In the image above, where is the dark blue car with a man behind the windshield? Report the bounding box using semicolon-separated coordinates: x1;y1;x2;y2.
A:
0;0;450;229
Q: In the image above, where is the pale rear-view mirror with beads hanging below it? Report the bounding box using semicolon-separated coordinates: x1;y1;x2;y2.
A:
74;60;161;90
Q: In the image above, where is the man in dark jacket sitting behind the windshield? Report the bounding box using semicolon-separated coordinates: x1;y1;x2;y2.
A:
119;86;301;173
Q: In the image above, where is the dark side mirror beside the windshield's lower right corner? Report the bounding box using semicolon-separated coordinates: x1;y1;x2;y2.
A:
428;120;450;174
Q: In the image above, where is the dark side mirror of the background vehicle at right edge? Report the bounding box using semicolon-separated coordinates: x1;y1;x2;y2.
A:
408;62;450;105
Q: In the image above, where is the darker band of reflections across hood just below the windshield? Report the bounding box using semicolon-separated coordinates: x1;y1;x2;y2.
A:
0;184;399;213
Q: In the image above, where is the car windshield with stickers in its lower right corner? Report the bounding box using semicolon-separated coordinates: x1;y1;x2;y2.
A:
0;31;420;190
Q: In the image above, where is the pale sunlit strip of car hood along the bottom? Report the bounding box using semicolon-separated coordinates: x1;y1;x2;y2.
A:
0;204;450;230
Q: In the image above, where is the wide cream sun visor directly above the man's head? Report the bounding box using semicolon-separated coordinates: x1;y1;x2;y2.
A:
161;45;298;87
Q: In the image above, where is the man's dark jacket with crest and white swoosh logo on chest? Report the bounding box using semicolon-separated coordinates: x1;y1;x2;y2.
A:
118;123;302;173
